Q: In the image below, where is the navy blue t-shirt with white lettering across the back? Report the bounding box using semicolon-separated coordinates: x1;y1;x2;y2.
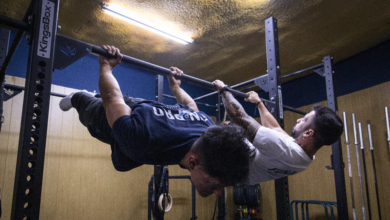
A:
111;101;214;167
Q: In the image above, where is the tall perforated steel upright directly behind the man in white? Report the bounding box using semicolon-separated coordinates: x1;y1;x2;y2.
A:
265;17;290;220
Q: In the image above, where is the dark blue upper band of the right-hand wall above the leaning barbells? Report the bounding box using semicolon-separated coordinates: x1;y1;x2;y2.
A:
282;40;390;108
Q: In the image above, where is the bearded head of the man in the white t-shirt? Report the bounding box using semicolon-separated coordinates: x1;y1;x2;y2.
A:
291;105;343;149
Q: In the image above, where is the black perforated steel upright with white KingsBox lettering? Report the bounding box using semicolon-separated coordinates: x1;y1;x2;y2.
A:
11;0;59;220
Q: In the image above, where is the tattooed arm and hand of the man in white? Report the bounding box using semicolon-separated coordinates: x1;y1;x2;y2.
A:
214;80;261;142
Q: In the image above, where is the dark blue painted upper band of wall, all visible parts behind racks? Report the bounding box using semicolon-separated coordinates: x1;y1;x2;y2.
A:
6;30;390;117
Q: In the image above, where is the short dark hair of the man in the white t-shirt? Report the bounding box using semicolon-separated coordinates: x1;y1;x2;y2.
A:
311;105;343;149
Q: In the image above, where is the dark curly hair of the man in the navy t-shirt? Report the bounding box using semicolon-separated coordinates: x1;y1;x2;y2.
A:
193;123;255;186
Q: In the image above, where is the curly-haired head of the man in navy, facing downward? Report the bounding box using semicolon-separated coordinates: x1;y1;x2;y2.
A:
189;123;254;197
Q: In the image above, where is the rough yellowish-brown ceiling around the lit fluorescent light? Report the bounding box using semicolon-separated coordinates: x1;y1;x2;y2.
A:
0;0;390;85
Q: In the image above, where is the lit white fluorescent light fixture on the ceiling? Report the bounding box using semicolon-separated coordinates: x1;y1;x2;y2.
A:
102;2;194;44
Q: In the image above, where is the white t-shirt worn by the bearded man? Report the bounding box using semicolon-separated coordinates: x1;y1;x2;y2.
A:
247;126;312;185
